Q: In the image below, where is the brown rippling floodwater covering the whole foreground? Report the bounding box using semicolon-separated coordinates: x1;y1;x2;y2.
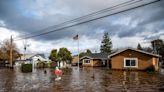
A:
0;67;164;92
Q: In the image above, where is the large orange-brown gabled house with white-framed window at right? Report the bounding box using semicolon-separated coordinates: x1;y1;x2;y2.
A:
108;48;159;70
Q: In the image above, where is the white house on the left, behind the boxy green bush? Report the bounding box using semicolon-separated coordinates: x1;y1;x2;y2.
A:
15;54;48;67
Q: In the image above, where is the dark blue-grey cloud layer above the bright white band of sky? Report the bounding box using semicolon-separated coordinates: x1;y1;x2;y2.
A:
0;0;164;41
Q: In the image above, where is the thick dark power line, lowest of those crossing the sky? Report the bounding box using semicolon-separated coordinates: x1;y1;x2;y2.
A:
14;0;161;40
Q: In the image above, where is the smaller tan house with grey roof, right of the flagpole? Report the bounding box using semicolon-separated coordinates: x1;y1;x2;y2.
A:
80;53;109;66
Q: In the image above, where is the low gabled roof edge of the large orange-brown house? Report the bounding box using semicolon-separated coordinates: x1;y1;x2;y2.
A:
108;48;160;58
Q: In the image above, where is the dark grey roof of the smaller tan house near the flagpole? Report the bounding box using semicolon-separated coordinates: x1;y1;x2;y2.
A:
80;53;108;59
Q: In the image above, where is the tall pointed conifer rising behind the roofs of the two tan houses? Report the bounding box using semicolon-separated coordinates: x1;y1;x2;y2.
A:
100;32;112;53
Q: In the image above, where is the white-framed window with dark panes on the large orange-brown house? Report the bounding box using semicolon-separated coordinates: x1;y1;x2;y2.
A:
124;58;138;67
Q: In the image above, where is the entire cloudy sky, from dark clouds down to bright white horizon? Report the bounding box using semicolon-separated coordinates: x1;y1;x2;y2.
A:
0;0;164;54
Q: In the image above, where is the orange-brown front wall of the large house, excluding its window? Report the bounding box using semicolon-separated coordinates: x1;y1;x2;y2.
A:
111;50;158;70
